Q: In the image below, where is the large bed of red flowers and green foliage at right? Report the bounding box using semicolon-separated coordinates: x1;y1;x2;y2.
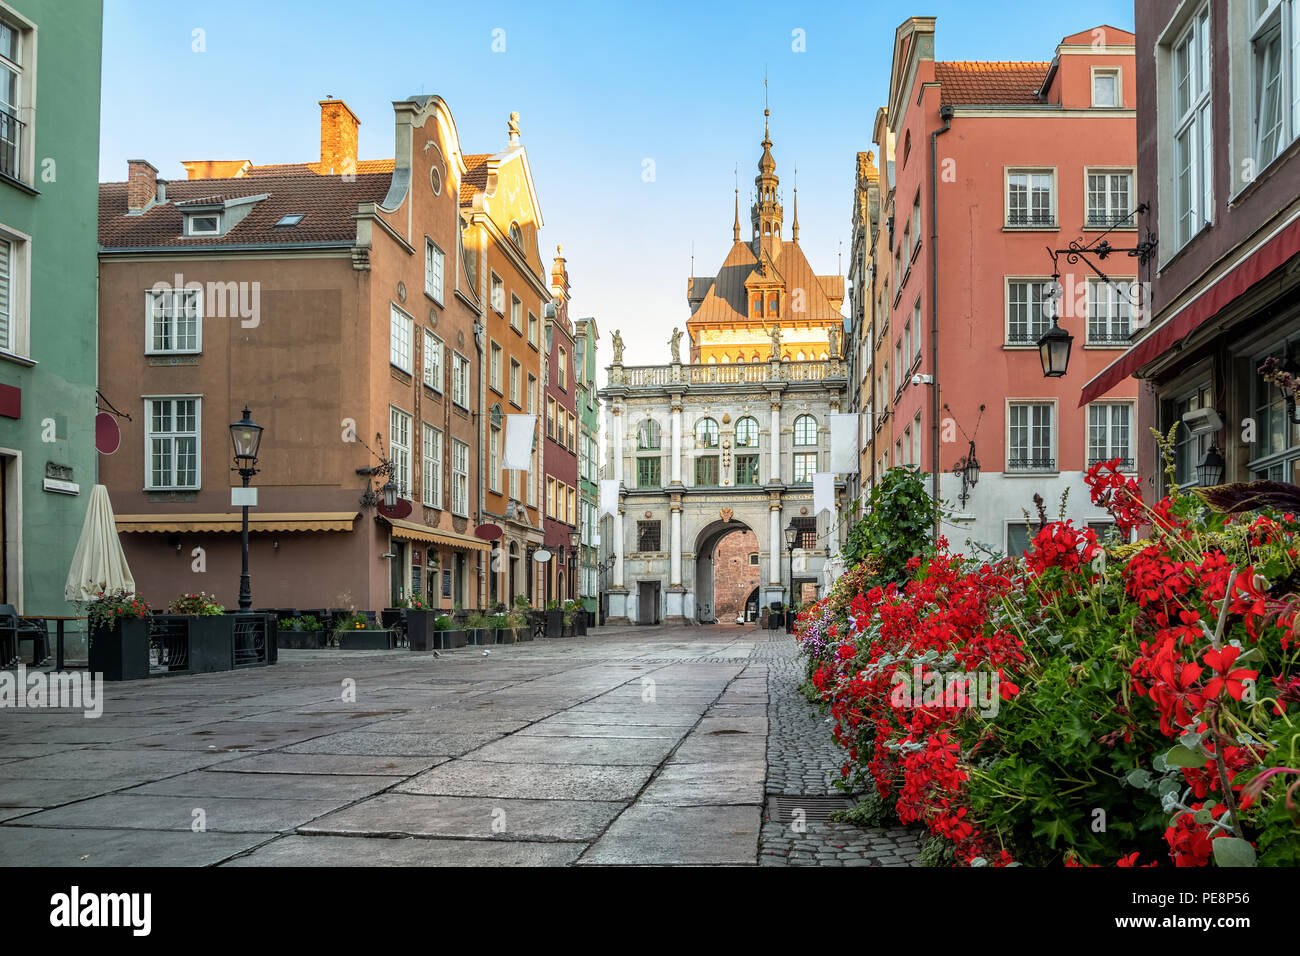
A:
797;463;1300;866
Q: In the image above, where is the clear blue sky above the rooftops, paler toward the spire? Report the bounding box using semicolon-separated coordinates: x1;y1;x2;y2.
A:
100;0;1134;390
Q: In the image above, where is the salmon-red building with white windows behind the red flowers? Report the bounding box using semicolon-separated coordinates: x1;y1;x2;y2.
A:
872;17;1139;553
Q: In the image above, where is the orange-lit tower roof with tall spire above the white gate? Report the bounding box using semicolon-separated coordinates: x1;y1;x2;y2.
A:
686;109;844;364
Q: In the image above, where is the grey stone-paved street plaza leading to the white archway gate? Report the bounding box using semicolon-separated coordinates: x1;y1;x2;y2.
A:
0;626;918;866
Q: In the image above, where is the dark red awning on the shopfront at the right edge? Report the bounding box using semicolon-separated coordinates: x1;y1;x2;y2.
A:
1079;220;1300;407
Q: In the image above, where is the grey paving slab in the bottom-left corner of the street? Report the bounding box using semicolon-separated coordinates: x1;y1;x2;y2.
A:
0;825;267;875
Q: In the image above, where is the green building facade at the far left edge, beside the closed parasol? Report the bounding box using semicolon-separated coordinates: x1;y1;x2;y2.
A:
0;0;103;614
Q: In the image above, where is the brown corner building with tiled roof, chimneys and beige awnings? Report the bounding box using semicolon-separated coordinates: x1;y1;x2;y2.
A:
99;96;489;609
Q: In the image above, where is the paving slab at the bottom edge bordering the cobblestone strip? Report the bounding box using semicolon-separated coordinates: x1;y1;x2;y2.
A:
579;804;761;866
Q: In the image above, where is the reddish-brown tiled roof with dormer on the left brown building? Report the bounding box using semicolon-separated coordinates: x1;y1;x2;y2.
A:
99;166;393;248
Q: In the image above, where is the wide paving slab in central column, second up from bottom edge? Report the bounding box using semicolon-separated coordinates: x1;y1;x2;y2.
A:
299;793;624;842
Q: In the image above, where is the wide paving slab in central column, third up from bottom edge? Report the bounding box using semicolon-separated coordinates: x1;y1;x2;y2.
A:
397;760;653;801
